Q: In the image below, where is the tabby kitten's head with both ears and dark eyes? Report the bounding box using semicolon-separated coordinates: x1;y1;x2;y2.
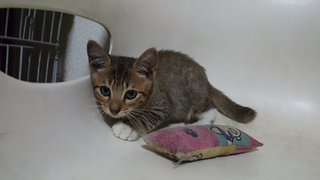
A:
87;41;157;118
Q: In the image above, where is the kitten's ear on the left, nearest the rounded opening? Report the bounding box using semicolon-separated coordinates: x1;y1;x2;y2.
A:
87;40;111;71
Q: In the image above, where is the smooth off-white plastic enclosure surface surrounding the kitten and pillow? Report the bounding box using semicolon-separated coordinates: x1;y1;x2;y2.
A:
0;0;320;180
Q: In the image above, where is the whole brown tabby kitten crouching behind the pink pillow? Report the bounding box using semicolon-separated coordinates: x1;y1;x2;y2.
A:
87;41;256;141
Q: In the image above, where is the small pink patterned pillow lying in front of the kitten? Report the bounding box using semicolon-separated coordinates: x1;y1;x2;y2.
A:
143;125;263;163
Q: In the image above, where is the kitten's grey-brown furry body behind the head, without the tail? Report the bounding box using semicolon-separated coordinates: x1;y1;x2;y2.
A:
156;50;215;121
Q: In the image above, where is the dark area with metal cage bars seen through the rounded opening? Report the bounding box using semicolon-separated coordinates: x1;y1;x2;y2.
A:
0;8;71;82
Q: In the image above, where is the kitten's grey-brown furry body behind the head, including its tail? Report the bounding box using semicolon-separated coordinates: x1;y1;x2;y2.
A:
156;50;256;123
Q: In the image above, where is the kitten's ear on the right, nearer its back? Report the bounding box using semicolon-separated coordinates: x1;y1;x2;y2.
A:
135;48;158;78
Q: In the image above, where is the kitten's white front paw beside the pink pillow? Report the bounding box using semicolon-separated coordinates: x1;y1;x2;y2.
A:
112;121;139;141
